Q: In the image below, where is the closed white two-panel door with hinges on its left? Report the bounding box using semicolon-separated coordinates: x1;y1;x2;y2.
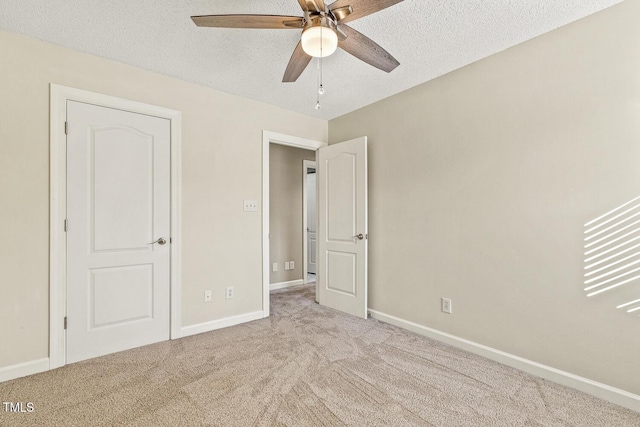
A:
66;101;170;363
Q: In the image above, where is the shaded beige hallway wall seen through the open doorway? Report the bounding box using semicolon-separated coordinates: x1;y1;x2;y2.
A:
269;144;316;283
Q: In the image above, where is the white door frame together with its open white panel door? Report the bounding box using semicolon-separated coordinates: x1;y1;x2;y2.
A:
262;131;368;318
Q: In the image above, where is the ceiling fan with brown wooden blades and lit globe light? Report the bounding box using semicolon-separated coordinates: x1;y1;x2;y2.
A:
191;0;403;82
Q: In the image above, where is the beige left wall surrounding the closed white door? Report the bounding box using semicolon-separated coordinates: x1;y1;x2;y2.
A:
0;31;327;367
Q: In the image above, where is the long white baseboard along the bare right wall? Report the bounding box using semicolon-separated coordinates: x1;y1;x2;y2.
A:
369;309;640;412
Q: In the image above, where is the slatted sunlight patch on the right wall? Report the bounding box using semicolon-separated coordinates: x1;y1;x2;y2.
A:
584;197;640;313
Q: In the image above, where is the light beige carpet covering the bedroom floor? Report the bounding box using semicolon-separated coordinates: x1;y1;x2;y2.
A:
0;286;640;427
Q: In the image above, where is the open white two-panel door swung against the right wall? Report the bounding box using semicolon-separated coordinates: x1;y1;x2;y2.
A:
317;137;368;319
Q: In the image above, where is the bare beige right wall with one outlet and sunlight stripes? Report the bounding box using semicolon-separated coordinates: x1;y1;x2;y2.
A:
329;1;640;394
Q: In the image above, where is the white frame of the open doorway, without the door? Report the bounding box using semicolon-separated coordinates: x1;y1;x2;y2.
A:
262;130;328;317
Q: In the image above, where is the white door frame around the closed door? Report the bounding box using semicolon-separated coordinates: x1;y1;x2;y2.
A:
49;83;182;369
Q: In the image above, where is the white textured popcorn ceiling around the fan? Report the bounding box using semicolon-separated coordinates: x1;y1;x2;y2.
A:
0;0;621;119
